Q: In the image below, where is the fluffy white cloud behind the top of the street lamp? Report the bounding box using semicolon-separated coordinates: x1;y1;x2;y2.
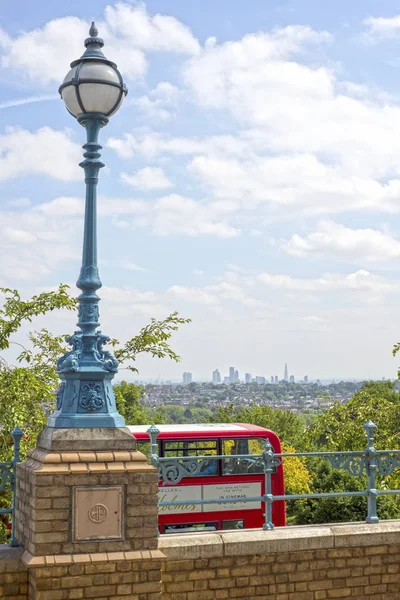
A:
0;3;199;84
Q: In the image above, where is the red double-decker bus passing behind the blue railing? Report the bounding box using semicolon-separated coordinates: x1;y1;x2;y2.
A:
129;423;286;533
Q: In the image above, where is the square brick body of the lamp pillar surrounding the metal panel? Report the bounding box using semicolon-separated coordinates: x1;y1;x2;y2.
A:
16;449;158;556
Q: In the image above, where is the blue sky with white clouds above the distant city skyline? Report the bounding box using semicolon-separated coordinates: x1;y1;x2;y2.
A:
0;0;400;379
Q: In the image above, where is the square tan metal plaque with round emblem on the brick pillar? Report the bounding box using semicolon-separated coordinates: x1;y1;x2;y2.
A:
73;486;123;542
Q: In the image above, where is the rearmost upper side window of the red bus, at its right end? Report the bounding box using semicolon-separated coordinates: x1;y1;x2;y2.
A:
222;438;265;475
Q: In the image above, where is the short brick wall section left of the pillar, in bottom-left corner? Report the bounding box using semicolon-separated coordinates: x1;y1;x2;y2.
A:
0;545;28;600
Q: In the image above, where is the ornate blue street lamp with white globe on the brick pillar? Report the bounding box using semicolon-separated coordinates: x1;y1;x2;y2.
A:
47;23;127;428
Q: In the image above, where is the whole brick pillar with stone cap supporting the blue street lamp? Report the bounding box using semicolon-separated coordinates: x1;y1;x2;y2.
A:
16;428;163;600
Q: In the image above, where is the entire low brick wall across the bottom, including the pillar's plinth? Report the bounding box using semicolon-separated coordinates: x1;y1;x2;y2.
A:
0;521;400;600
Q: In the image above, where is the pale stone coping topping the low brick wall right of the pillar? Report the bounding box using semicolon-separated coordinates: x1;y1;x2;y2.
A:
158;520;400;560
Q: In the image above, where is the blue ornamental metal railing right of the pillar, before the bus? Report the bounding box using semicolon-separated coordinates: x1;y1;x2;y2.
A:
147;421;400;530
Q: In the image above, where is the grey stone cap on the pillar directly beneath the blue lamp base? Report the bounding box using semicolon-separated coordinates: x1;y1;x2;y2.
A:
36;427;136;452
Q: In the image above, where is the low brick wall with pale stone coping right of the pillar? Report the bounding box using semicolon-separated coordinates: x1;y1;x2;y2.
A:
159;521;400;600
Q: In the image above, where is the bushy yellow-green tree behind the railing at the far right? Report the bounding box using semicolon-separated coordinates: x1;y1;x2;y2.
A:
290;381;400;524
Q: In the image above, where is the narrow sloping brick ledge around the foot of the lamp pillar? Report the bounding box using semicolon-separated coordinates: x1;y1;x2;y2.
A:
21;550;166;569
